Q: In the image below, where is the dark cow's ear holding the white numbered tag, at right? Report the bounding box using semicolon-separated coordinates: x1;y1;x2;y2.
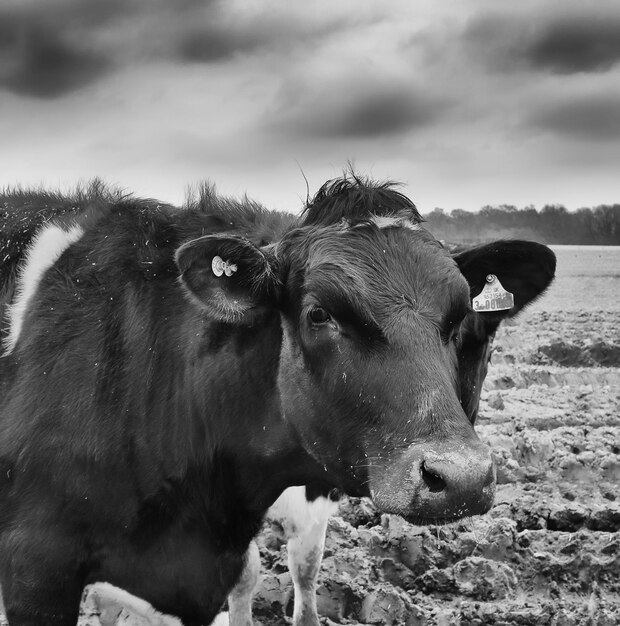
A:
454;240;555;325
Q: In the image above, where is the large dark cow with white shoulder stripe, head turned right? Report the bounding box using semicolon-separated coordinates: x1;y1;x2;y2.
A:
0;177;552;626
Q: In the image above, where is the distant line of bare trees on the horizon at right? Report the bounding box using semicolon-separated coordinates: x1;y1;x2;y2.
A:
424;204;620;245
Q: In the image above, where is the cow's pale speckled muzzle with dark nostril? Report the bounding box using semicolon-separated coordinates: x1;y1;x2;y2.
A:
369;438;495;523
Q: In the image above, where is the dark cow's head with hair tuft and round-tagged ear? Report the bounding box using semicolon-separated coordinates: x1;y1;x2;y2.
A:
177;179;548;520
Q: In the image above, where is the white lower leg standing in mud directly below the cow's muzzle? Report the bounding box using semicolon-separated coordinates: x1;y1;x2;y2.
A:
288;515;329;626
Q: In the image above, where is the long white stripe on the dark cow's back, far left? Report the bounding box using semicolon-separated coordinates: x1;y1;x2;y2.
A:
3;224;84;356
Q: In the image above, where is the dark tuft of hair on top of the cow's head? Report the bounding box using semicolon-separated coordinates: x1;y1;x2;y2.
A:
302;171;423;226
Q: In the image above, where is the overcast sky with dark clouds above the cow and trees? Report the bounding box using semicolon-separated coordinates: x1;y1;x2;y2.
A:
0;0;620;212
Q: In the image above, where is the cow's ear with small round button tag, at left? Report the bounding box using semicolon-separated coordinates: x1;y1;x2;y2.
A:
175;235;279;323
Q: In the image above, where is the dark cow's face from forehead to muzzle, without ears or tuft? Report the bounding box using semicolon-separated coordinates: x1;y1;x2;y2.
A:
280;220;494;518
